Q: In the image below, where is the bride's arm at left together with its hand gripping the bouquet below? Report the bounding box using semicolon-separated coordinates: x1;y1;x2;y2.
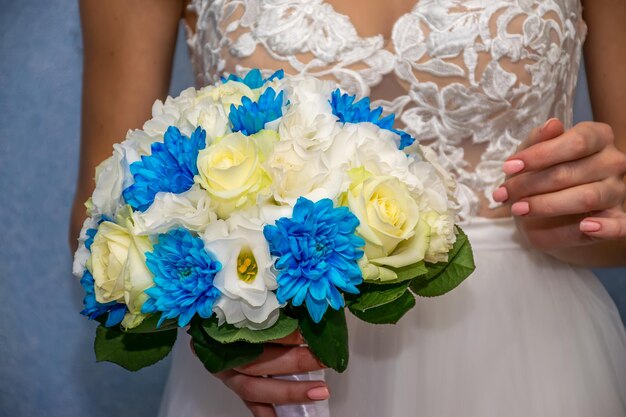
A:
70;4;328;417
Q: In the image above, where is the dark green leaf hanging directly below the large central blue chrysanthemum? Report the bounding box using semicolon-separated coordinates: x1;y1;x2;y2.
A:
297;309;350;372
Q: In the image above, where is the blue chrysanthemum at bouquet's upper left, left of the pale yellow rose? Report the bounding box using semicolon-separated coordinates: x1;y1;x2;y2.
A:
123;126;206;211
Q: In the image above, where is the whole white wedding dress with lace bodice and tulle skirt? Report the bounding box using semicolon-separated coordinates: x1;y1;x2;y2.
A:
160;0;626;417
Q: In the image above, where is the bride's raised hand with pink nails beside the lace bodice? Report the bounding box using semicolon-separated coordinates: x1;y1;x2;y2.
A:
493;119;626;252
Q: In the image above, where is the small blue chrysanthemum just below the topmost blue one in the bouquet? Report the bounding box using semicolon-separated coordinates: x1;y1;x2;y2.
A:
228;87;283;136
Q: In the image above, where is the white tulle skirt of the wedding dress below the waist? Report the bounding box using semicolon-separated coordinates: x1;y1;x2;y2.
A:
160;219;626;417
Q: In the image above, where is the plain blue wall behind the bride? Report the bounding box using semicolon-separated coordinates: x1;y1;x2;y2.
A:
0;0;626;417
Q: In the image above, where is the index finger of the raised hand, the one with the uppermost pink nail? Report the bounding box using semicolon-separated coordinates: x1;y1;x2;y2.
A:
503;123;613;174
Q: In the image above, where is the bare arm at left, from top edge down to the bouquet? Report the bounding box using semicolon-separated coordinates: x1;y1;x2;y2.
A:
70;0;183;249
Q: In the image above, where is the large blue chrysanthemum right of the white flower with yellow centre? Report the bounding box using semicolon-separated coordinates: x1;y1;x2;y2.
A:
263;197;365;323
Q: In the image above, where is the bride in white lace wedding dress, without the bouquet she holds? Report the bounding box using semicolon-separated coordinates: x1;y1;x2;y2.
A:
73;0;626;417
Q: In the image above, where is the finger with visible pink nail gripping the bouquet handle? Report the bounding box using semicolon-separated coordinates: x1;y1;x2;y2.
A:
222;371;330;404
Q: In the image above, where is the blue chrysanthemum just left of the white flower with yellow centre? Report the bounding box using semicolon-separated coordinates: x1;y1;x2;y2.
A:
141;229;222;327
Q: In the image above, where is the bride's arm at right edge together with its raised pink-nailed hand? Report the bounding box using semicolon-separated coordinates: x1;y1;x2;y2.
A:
494;0;626;266
